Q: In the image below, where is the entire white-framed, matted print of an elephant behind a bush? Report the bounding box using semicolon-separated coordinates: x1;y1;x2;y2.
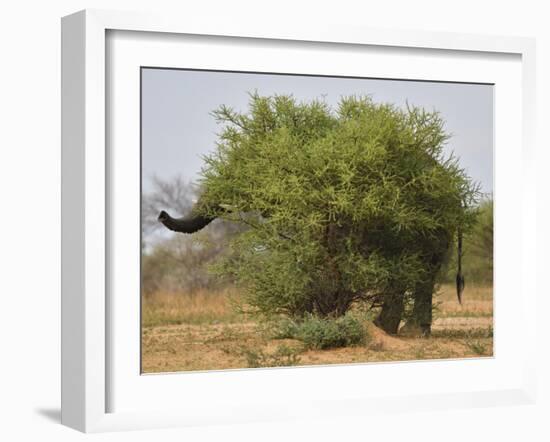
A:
62;11;536;431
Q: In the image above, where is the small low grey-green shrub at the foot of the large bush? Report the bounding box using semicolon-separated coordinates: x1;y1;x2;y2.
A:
275;313;368;350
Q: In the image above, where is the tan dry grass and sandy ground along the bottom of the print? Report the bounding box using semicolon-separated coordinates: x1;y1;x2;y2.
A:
142;286;493;373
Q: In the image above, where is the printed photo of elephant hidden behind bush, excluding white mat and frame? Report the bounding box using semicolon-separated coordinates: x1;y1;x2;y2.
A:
140;66;494;374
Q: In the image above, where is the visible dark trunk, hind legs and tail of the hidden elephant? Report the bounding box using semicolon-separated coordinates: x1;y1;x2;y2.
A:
158;202;465;336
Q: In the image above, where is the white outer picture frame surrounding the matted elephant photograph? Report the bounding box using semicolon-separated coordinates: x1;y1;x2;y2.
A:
62;10;537;432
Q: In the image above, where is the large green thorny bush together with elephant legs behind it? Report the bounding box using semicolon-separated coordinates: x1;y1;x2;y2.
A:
163;94;476;332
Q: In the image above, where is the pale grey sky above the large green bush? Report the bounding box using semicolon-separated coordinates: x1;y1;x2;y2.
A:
142;69;493;192
